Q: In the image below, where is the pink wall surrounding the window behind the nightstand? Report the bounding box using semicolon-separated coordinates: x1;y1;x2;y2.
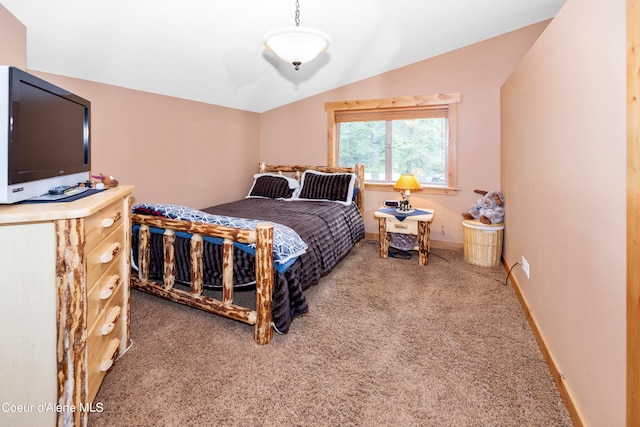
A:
260;22;548;247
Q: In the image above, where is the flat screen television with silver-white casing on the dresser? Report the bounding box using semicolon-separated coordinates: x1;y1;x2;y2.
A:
0;65;91;204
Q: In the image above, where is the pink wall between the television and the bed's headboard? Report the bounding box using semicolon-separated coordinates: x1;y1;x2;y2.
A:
30;70;259;208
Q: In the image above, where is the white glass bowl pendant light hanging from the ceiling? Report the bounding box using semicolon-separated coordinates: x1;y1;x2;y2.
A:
263;0;331;70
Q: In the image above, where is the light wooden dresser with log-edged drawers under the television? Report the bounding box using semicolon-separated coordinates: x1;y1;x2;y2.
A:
0;185;133;426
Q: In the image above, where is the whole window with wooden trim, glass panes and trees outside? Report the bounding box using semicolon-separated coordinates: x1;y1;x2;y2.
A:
325;93;460;193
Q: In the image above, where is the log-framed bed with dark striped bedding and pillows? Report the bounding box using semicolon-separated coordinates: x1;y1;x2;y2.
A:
131;163;364;344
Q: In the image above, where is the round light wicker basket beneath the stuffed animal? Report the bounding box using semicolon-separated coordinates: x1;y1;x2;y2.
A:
462;219;504;267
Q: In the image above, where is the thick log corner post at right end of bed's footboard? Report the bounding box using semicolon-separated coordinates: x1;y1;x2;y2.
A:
254;223;274;344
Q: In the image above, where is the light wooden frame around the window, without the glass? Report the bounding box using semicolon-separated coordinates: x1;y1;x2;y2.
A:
325;92;461;194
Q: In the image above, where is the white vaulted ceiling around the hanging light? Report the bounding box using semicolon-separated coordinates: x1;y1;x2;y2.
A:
0;0;565;112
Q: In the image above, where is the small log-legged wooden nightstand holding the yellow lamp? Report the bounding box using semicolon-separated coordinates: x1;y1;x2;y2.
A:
373;208;435;265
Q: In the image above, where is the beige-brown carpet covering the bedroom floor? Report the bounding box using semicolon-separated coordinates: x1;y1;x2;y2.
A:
89;243;571;427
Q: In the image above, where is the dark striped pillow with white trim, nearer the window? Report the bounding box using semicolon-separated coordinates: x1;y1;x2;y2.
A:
297;170;356;205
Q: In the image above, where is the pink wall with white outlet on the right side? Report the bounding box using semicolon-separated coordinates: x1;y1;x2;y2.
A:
501;0;626;426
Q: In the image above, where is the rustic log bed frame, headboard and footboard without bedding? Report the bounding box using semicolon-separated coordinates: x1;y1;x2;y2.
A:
131;162;364;345
